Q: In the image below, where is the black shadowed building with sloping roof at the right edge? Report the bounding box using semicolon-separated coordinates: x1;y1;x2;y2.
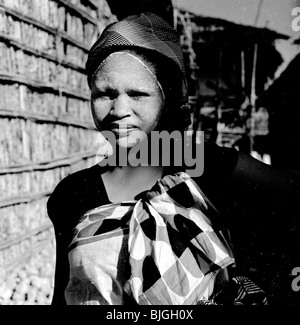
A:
257;39;300;170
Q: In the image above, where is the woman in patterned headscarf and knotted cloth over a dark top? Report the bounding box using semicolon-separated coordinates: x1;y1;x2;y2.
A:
48;13;299;305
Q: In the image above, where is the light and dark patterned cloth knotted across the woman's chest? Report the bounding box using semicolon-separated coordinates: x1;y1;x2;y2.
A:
65;172;234;305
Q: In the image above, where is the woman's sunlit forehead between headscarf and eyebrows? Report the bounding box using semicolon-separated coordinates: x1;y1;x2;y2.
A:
94;52;158;89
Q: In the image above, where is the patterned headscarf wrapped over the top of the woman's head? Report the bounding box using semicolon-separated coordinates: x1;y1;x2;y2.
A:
86;12;187;101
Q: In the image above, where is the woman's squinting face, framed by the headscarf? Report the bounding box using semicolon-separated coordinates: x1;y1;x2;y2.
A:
91;52;165;148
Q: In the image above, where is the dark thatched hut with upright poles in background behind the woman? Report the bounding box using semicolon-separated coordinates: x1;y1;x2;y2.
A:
174;9;288;158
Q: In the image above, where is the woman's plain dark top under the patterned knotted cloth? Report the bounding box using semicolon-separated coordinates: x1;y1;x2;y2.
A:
47;143;300;304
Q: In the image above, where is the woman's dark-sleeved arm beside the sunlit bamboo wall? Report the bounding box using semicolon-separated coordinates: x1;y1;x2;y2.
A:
47;166;108;305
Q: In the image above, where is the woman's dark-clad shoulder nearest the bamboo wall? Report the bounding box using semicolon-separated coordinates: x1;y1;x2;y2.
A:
47;165;106;227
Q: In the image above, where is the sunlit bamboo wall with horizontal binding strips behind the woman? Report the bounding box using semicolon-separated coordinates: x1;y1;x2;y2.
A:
0;0;111;305
